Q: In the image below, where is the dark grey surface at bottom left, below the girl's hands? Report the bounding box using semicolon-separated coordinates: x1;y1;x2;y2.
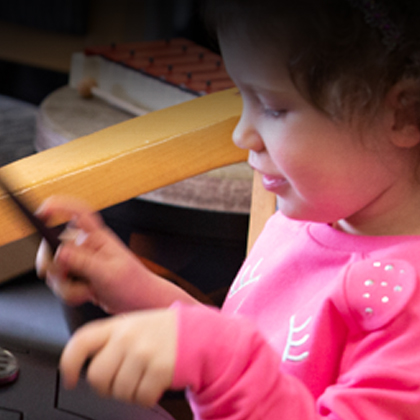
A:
0;273;172;420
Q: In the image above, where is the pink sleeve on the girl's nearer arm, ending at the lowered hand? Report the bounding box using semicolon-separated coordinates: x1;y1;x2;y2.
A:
172;305;319;420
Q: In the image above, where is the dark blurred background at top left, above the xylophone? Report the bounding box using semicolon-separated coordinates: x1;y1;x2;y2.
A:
0;0;207;104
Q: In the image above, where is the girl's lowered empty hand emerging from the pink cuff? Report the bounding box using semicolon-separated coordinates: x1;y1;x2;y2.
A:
60;310;177;407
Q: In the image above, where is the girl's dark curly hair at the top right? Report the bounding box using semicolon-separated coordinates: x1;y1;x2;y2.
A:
204;0;420;126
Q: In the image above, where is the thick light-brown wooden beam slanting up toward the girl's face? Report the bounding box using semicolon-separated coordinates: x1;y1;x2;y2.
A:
0;89;247;246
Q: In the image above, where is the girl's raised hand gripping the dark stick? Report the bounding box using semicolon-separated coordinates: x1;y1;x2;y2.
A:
36;197;152;313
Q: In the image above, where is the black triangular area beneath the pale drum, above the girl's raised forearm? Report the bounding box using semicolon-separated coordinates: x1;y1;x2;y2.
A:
102;199;249;293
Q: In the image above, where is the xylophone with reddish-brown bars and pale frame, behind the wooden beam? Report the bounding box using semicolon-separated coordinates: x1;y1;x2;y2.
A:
70;38;238;115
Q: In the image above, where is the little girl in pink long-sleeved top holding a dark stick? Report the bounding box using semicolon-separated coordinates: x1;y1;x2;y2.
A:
38;0;420;420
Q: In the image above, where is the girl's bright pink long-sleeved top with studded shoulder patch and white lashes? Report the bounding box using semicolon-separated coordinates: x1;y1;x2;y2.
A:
173;213;420;420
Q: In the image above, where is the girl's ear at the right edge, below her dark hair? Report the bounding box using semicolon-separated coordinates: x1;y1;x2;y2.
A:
386;80;420;148
